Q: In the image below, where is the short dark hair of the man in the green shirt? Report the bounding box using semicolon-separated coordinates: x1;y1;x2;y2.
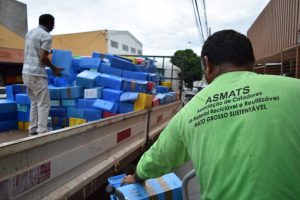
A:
201;30;255;67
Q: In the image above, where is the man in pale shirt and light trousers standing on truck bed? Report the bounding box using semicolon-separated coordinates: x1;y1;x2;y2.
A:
22;14;62;135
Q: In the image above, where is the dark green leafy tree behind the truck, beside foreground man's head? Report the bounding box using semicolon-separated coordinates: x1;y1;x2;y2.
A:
171;49;203;87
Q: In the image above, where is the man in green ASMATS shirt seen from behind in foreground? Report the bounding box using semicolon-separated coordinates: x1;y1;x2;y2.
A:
123;30;300;200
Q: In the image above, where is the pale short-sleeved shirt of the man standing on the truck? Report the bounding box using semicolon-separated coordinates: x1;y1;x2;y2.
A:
22;25;52;77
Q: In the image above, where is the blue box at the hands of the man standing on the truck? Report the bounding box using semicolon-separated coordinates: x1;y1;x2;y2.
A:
52;49;74;84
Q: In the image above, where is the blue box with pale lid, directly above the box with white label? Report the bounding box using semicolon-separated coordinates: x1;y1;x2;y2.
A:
76;70;99;88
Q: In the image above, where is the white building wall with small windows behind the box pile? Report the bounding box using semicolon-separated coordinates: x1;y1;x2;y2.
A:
107;30;143;55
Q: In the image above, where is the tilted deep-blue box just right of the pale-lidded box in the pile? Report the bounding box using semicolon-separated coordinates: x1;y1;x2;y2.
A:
97;74;123;90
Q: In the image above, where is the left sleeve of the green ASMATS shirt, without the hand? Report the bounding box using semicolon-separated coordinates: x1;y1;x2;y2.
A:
136;114;190;180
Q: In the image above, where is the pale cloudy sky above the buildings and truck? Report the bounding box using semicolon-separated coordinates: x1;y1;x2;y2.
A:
18;0;270;56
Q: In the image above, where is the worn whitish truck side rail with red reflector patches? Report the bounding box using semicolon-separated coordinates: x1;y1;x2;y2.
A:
0;101;181;200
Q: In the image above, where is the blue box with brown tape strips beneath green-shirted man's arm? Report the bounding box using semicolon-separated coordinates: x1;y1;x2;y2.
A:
118;173;182;200
